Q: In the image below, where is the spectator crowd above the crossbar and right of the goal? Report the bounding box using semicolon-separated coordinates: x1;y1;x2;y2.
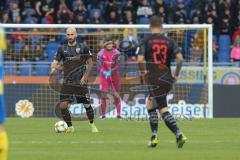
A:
0;0;240;62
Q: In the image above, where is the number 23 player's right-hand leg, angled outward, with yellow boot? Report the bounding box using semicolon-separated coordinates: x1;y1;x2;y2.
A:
158;96;187;148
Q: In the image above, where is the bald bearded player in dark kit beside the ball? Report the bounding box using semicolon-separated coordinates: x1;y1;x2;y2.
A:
51;28;98;133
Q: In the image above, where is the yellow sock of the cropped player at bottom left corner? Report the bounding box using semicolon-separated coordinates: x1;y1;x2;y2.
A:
0;131;8;160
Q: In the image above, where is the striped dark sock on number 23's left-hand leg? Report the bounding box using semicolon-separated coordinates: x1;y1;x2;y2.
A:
148;109;158;136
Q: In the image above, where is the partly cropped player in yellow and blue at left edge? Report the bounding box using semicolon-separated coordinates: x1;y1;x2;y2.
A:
0;28;8;160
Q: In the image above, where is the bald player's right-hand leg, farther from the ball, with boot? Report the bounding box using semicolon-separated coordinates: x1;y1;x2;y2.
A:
76;96;98;133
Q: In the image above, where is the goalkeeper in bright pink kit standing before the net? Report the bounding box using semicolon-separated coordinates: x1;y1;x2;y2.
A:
97;38;122;119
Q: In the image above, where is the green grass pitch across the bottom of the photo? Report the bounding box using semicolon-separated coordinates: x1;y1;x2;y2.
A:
6;118;240;160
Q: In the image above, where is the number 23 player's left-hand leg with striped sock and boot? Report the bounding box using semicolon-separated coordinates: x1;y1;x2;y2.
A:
147;98;158;147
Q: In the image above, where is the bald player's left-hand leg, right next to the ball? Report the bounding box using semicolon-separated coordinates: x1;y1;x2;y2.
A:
59;94;74;132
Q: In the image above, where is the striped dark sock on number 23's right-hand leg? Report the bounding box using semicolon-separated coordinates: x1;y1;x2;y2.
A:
162;112;181;137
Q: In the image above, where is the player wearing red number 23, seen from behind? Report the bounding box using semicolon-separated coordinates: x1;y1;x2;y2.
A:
136;16;187;148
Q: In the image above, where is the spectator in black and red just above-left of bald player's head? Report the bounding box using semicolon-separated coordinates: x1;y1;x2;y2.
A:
57;4;73;24
